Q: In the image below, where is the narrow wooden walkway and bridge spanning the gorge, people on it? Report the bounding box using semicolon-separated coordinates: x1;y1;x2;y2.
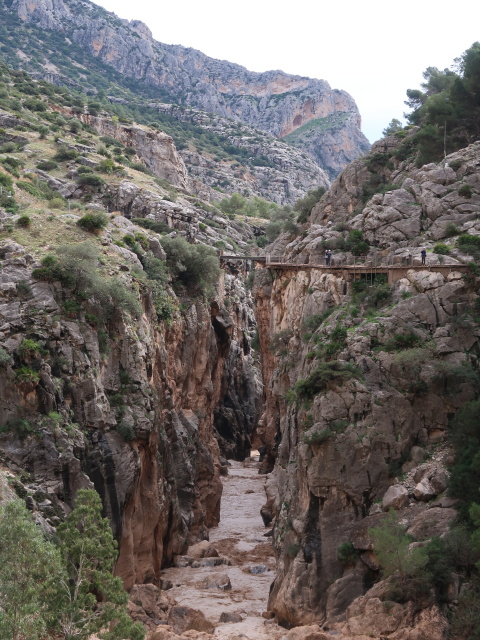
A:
220;253;469;285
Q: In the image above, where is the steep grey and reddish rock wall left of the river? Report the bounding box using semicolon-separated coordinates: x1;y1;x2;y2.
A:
0;236;255;587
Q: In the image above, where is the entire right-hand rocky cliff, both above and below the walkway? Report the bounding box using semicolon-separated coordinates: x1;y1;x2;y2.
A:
251;140;480;639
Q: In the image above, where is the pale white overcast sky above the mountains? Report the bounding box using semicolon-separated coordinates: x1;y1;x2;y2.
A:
92;0;480;142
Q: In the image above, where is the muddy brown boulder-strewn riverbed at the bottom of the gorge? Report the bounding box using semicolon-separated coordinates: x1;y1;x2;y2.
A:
162;461;285;640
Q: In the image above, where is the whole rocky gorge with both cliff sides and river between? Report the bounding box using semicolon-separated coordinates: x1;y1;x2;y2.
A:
0;27;480;640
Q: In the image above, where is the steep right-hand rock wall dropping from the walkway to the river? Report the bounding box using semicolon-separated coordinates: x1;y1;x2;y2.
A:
255;269;480;626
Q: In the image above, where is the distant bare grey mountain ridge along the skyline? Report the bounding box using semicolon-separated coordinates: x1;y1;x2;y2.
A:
4;0;369;177
